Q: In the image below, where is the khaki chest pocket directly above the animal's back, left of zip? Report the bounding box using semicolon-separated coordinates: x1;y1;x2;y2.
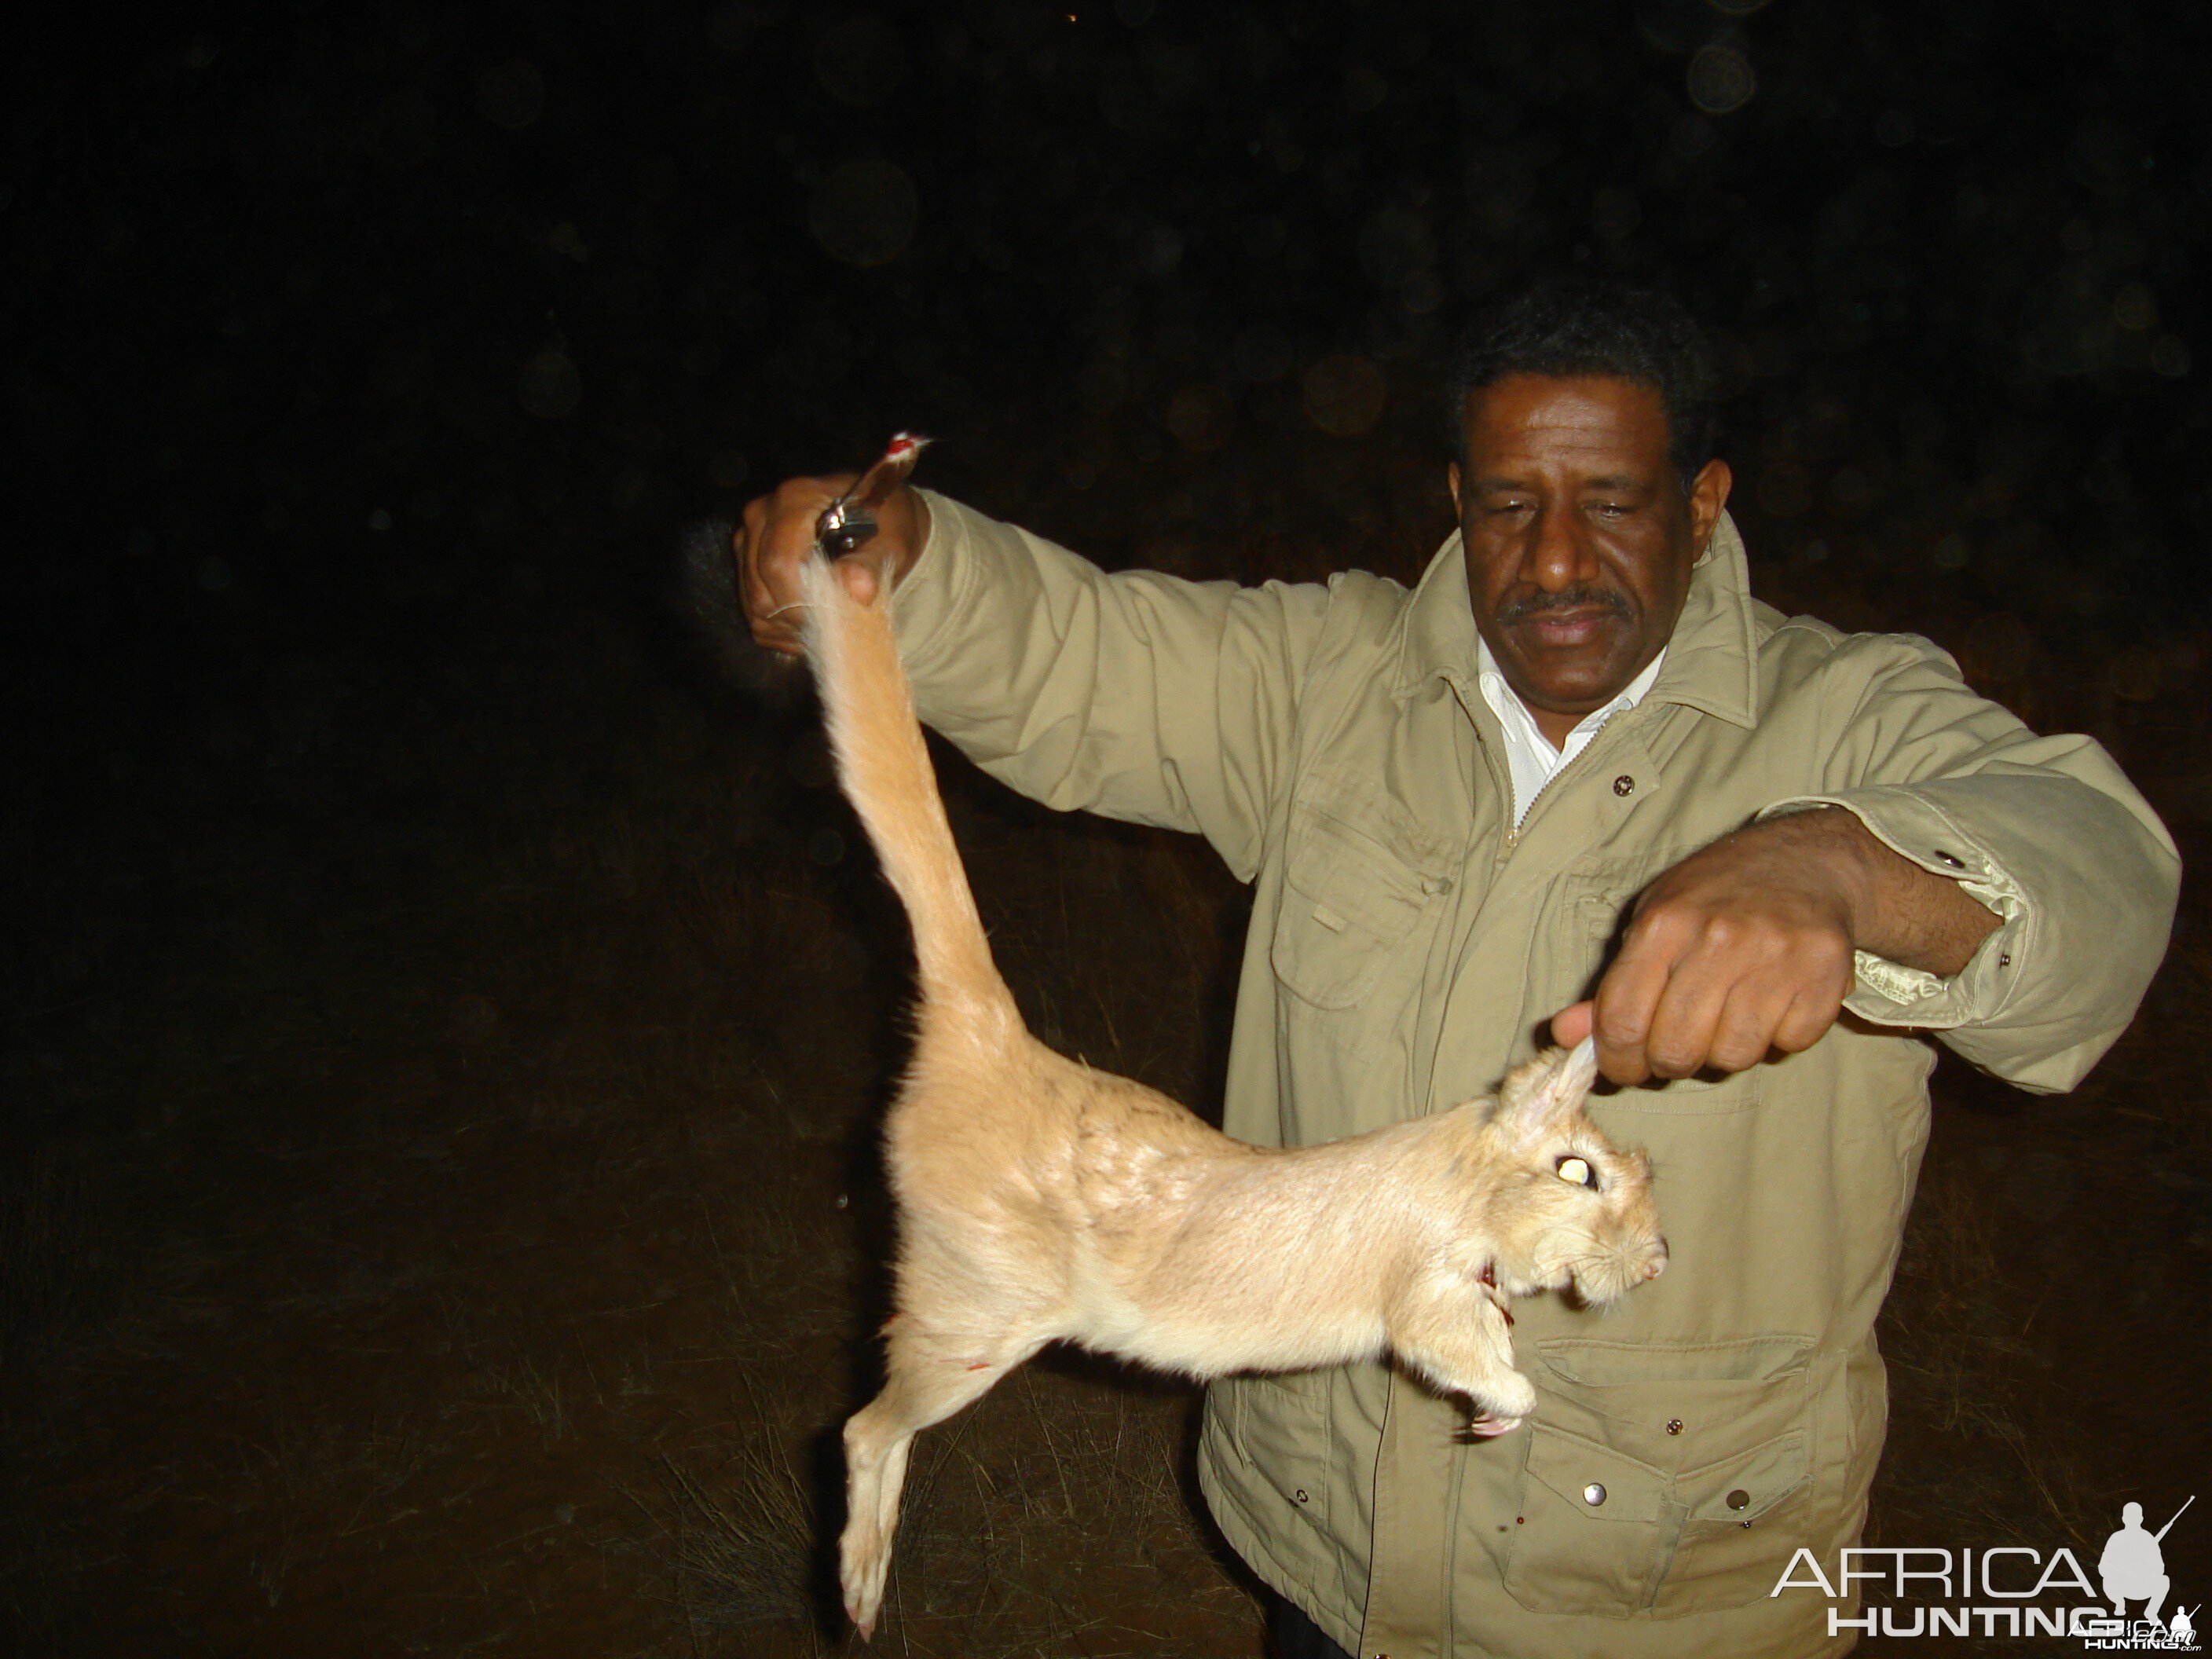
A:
1269;800;1453;1009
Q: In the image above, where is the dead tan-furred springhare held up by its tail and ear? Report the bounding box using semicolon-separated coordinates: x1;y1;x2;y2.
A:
805;558;1665;1637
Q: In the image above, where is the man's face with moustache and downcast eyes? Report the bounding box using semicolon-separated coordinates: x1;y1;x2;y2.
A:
1451;374;1730;743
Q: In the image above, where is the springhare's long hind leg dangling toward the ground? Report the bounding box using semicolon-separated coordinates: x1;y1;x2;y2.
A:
836;1320;1044;1639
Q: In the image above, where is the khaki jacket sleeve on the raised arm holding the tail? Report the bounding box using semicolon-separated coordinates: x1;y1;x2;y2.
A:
892;493;1329;881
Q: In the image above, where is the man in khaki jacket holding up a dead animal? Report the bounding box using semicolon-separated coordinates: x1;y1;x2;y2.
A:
739;285;2179;1659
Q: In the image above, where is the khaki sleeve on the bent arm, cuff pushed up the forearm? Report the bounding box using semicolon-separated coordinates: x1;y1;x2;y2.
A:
1761;635;2181;1093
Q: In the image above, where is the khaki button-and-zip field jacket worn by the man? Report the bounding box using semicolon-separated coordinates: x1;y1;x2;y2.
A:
894;496;2179;1659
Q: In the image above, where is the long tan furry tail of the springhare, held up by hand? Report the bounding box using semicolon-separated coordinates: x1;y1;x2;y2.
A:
803;553;1017;1020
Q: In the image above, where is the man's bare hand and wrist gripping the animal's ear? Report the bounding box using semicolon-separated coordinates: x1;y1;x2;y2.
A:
1551;808;1998;1084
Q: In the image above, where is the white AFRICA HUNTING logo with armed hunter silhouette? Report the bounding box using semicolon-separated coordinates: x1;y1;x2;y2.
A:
1767;1493;2203;1653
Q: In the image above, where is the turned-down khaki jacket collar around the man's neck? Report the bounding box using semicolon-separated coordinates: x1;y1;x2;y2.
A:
1396;513;1759;727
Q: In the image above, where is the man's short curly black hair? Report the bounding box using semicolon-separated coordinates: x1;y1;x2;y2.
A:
1445;276;1719;493
